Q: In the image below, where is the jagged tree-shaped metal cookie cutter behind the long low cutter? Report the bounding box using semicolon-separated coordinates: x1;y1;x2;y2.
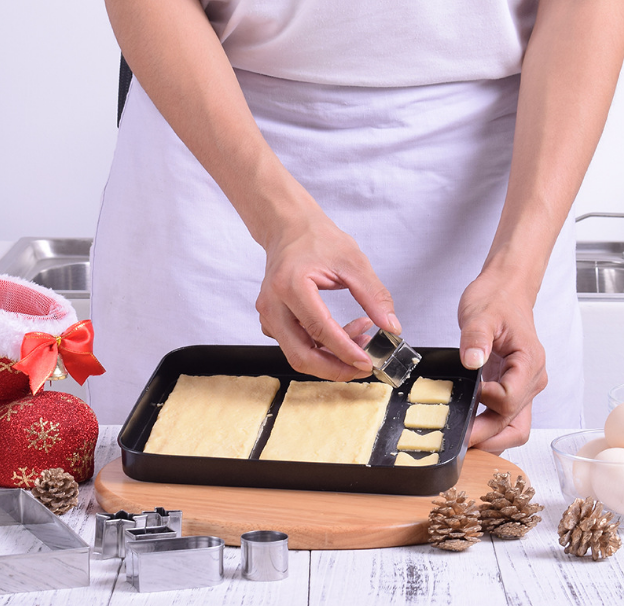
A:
93;507;182;560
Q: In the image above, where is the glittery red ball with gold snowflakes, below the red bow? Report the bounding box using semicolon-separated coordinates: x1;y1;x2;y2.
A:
0;391;98;488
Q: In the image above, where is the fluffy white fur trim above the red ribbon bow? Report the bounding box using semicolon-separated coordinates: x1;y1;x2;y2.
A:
0;274;78;362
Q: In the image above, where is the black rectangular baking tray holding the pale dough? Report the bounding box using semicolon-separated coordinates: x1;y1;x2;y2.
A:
118;345;481;495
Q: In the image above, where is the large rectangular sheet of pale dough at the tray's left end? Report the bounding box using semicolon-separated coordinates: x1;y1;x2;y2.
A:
144;375;280;459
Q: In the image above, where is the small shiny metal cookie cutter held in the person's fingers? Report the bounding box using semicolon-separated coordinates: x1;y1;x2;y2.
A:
364;328;422;387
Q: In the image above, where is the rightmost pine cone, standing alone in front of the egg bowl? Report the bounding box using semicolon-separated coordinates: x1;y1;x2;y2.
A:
557;497;622;561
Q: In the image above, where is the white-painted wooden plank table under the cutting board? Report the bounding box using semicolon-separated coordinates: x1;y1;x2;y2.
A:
0;426;624;606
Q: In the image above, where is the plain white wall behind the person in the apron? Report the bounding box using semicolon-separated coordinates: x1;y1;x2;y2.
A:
0;5;624;241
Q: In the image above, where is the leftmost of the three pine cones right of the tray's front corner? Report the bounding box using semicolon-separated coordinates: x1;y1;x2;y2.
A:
428;488;483;551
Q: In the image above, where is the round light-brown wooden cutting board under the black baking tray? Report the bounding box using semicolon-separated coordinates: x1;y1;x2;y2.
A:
95;449;526;549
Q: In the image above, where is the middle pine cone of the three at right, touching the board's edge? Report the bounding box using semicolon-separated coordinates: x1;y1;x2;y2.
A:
479;471;544;539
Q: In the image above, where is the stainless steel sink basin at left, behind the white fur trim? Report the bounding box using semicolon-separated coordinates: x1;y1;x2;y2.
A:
0;238;93;299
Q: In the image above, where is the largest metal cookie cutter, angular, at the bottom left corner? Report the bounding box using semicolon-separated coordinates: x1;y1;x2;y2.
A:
0;488;90;595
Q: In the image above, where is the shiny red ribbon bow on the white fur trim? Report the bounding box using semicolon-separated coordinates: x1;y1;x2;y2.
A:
13;320;105;394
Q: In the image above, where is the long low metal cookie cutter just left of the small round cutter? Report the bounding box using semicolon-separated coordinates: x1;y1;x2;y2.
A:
126;536;224;593
